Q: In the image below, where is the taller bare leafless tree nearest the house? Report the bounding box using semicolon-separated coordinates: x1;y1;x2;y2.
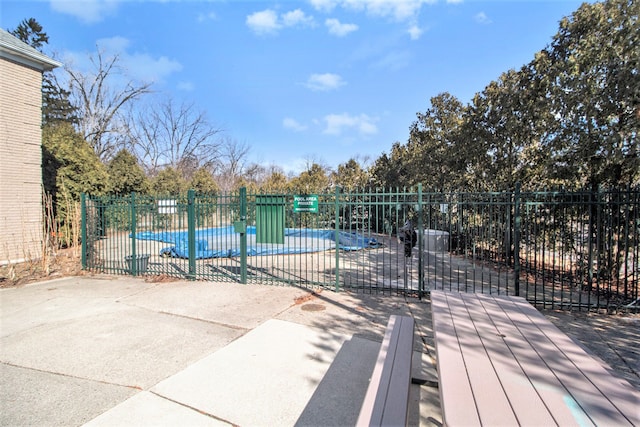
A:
65;49;151;162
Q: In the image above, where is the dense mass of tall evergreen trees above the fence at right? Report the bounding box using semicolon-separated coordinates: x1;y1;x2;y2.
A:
371;0;640;190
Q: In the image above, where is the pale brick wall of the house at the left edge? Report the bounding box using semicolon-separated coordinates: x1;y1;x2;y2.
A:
0;58;43;264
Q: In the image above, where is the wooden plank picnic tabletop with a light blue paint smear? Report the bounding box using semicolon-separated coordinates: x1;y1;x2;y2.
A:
431;291;640;426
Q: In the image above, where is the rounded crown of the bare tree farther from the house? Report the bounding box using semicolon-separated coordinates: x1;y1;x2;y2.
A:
127;98;222;179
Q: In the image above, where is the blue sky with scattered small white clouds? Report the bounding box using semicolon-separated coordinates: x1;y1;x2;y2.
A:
0;0;582;174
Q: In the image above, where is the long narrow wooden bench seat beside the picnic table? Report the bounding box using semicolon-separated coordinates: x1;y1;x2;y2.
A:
356;315;414;426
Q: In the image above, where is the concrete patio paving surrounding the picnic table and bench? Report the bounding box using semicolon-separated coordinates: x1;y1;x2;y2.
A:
0;276;640;426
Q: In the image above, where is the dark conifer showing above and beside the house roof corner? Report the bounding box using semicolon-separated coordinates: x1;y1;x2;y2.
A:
9;18;78;126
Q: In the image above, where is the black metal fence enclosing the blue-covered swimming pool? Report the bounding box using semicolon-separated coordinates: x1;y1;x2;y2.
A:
82;186;640;311
